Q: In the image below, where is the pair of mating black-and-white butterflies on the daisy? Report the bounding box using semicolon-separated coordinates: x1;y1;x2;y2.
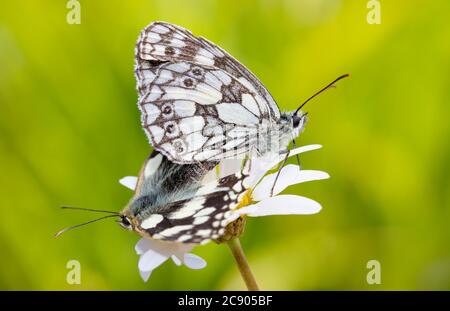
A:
58;22;347;243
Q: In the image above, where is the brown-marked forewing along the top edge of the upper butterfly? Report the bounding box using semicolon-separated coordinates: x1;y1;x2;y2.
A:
135;22;280;119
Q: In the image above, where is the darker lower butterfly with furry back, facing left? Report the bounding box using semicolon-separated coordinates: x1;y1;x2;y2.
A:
57;151;249;244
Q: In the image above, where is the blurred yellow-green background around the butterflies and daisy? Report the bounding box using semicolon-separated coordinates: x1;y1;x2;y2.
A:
0;0;450;290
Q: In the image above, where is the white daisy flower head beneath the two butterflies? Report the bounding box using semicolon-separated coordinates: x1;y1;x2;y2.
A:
120;145;329;281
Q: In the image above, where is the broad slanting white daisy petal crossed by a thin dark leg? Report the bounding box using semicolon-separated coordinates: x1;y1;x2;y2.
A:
252;164;300;201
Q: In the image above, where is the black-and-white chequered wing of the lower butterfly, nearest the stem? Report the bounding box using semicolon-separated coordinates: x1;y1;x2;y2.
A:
137;162;249;244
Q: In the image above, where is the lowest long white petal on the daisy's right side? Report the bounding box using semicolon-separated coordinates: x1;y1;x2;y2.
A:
247;194;322;217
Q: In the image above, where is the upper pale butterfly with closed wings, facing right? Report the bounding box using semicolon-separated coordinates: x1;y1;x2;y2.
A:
135;22;324;164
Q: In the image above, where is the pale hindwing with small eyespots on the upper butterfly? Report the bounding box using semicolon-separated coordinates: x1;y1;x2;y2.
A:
139;62;270;164
